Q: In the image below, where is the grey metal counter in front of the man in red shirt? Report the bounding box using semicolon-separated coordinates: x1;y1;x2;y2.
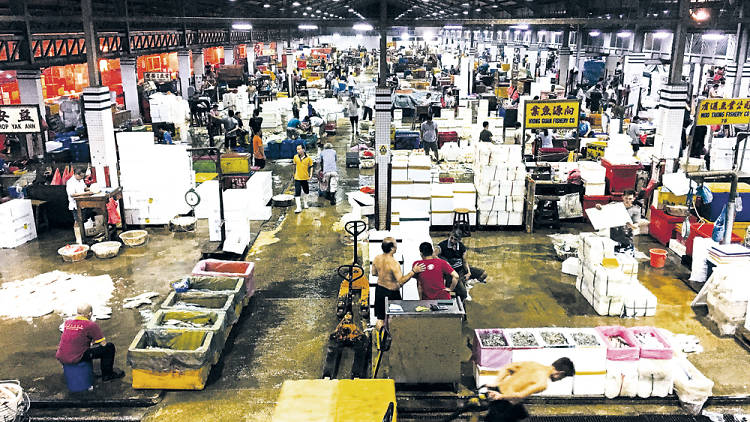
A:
383;299;466;390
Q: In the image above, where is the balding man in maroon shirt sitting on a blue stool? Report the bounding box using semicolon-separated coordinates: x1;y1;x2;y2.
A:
55;303;125;381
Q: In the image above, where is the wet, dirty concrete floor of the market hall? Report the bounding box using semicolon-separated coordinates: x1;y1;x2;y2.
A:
0;95;750;422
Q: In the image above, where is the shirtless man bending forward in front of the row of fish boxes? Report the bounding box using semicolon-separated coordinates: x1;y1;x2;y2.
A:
485;358;575;422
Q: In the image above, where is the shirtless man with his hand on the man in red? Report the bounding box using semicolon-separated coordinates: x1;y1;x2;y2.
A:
372;237;425;330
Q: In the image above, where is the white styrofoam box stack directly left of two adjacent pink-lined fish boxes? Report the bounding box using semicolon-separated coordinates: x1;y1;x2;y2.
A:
566;328;607;396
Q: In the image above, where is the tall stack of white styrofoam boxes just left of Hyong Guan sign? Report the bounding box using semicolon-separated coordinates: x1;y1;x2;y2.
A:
474;142;526;226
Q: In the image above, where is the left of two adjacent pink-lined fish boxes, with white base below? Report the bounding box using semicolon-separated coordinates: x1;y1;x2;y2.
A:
596;326;641;399
